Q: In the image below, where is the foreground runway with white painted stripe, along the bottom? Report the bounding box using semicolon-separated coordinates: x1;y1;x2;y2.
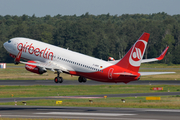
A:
0;106;180;120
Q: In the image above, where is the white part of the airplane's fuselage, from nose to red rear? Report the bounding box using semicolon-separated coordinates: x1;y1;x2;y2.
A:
4;37;113;73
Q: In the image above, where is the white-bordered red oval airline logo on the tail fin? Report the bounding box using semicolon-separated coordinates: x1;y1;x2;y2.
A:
129;40;147;67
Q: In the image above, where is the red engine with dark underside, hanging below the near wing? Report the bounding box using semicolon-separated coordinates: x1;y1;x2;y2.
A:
25;61;47;74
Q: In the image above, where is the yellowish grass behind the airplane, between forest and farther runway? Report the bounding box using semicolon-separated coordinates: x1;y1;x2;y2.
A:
0;63;180;80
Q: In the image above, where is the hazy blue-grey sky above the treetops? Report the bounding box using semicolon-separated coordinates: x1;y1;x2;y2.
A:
0;0;180;17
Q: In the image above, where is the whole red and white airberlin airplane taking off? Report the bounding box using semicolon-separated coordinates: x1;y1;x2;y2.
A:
3;32;174;83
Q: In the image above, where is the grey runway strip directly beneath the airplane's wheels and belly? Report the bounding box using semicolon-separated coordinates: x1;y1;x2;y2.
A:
0;80;180;86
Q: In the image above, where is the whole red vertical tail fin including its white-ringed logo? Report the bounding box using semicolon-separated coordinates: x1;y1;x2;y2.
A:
116;33;150;72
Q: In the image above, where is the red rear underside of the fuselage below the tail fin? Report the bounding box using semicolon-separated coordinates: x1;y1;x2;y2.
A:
70;65;140;83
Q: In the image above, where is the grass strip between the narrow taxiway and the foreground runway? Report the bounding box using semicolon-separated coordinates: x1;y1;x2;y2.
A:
0;96;180;109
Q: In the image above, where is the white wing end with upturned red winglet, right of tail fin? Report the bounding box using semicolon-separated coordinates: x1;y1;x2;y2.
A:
141;46;169;63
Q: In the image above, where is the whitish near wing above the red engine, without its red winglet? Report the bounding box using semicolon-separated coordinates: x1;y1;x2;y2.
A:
20;61;69;72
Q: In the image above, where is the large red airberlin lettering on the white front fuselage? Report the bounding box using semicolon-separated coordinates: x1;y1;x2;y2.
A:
17;42;53;60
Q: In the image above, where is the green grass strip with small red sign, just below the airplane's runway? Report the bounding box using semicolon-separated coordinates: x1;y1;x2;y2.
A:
0;85;180;98
